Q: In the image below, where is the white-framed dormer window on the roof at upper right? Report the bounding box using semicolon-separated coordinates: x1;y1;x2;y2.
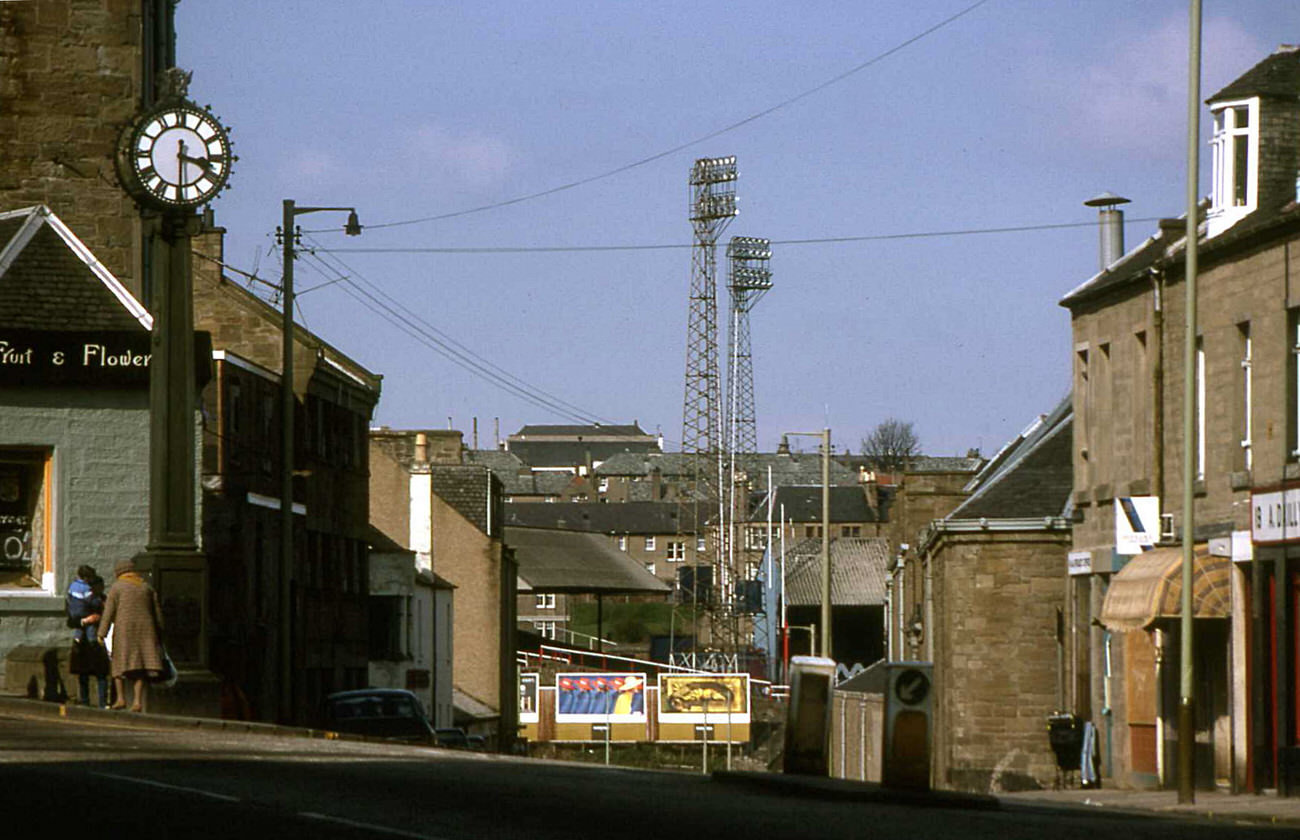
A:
1209;99;1260;237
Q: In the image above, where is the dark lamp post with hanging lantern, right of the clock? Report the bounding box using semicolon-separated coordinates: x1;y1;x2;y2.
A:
278;199;361;723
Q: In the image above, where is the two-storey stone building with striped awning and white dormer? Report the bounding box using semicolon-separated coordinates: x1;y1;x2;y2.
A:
1061;47;1300;791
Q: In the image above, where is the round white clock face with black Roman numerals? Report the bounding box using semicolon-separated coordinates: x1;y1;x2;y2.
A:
122;104;231;207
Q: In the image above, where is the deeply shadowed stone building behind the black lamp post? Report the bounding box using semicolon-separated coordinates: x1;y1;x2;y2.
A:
194;229;381;722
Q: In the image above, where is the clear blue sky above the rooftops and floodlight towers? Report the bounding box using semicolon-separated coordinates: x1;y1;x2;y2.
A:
177;0;1300;455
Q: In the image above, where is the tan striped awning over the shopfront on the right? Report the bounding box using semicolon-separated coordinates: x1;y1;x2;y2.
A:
1101;544;1232;631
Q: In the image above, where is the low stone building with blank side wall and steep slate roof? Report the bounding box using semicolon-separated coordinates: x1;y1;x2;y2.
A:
909;398;1073;792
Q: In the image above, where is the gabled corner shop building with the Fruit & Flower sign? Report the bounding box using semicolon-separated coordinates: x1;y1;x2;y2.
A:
0;205;157;700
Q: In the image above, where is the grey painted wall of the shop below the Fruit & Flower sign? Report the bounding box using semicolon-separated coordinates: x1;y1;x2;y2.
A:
0;389;148;681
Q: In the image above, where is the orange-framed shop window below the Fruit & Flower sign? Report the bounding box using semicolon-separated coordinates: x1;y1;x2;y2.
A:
0;449;55;592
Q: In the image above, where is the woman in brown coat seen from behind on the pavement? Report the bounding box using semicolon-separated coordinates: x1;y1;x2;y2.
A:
99;555;164;711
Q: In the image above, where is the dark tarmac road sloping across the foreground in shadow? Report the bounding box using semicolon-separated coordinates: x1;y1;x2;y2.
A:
0;714;1282;840
